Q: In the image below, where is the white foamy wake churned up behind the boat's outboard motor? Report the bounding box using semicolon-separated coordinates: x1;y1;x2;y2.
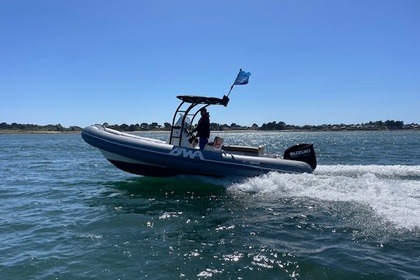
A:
230;165;420;230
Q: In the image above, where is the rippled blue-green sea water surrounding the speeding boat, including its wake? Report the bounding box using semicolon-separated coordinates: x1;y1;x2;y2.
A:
0;131;420;279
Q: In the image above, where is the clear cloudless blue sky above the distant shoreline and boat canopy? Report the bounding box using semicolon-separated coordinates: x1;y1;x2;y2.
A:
0;0;420;127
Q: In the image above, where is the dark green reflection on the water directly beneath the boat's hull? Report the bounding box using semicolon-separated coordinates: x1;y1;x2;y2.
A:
86;176;226;217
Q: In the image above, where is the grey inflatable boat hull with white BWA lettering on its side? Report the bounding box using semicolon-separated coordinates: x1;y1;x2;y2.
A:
82;125;312;177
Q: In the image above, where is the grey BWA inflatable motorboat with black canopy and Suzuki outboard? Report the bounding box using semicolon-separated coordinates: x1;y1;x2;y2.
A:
82;71;317;177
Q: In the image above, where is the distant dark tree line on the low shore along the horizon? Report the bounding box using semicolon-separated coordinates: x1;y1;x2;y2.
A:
0;120;420;132
